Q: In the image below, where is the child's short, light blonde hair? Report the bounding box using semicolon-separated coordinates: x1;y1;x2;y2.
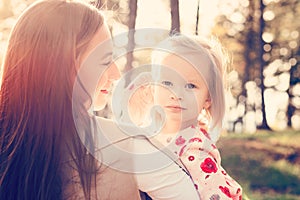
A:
151;34;228;138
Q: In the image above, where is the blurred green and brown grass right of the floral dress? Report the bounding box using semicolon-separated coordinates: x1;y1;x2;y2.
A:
218;131;300;200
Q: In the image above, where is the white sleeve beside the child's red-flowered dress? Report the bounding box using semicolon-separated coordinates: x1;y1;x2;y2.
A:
135;140;200;200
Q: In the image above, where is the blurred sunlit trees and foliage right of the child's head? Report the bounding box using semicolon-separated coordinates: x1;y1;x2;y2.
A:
213;0;300;132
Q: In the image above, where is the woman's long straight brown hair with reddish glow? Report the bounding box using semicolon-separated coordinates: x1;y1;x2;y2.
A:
0;0;103;200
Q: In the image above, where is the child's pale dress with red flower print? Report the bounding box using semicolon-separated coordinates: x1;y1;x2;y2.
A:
170;126;242;200
